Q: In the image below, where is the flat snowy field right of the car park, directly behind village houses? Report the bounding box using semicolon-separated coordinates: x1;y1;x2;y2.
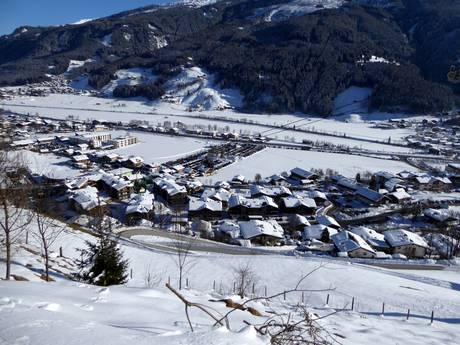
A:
201;148;416;182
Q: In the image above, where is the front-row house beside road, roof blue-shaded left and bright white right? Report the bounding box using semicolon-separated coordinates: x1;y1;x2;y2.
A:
331;230;376;258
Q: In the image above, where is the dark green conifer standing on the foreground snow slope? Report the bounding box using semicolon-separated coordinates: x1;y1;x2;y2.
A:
77;236;128;286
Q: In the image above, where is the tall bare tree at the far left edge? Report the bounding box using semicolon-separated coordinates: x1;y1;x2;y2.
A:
0;150;31;280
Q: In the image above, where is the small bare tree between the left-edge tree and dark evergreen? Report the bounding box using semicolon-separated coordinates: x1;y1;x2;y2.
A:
32;212;65;281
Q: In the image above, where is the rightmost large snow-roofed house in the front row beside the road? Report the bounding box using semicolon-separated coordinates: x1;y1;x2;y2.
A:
383;230;428;258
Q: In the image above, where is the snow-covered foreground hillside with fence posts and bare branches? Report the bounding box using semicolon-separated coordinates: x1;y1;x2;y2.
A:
0;219;460;345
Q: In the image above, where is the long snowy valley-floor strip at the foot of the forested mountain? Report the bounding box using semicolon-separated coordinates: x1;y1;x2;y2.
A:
1;94;412;152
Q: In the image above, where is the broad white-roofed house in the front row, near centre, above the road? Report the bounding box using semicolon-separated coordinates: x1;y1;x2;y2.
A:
239;220;284;245
